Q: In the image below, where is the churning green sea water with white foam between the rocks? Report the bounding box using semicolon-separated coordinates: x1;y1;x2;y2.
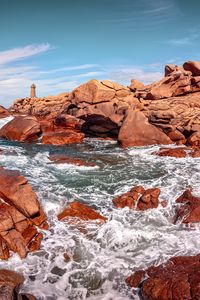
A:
0;121;200;300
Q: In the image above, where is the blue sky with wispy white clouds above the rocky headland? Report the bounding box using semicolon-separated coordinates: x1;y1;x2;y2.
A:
0;0;200;107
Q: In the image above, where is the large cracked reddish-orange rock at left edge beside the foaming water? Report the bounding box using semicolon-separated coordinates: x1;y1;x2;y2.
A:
0;167;48;259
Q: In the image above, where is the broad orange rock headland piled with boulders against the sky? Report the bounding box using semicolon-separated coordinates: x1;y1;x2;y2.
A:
6;62;200;146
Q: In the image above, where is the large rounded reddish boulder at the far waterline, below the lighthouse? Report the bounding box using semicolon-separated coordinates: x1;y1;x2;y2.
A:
0;116;41;142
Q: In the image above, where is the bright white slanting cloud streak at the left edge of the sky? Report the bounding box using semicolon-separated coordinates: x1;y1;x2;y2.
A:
0;43;50;65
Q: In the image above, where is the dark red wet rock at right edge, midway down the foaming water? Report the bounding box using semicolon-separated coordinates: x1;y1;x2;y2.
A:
175;190;200;224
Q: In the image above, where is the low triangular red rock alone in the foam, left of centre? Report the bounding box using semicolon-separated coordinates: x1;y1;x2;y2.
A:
58;201;107;222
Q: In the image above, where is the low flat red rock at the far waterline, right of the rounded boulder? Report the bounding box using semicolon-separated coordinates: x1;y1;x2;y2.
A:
42;130;85;146
